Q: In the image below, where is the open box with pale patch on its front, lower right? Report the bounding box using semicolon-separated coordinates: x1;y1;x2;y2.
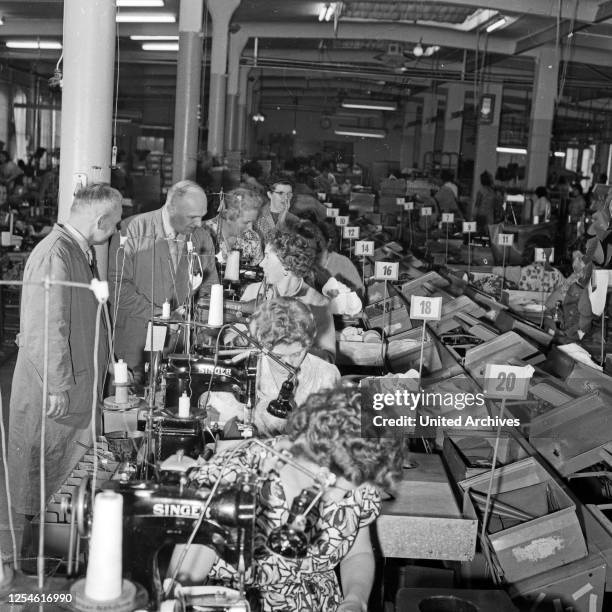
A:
460;457;587;582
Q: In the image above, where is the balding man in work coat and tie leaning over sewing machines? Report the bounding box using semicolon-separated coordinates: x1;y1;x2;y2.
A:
108;180;218;382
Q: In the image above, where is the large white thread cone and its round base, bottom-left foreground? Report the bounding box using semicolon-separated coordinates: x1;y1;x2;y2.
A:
70;491;136;612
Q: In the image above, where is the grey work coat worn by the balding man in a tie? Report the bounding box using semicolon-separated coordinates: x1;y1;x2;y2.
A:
108;209;218;369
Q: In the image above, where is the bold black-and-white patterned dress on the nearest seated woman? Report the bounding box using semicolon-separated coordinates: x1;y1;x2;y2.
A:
194;443;381;612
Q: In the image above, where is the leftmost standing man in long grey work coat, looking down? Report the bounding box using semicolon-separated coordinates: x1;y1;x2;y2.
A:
8;184;121;516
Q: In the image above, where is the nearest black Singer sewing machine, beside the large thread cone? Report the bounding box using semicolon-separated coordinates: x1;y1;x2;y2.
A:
104;480;256;610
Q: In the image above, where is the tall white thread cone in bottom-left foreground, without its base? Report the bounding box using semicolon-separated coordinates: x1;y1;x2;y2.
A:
85;491;123;601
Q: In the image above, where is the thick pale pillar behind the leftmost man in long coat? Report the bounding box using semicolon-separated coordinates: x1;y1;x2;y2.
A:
58;0;116;278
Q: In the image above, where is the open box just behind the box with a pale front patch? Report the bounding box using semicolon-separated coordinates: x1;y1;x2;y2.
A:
442;429;529;483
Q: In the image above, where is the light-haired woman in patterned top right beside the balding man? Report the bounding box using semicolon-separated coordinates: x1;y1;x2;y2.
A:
206;187;264;266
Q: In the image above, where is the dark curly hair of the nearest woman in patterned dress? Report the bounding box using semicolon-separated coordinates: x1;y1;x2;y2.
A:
286;387;403;491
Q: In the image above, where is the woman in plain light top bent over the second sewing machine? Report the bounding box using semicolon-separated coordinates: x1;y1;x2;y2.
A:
206;297;340;439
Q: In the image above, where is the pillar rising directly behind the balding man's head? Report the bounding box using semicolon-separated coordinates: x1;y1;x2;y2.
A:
172;0;204;183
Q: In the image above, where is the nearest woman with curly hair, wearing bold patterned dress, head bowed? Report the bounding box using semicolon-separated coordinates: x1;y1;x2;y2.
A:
172;388;402;612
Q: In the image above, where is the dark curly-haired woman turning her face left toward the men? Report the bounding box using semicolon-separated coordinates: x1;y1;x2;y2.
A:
241;222;336;363
